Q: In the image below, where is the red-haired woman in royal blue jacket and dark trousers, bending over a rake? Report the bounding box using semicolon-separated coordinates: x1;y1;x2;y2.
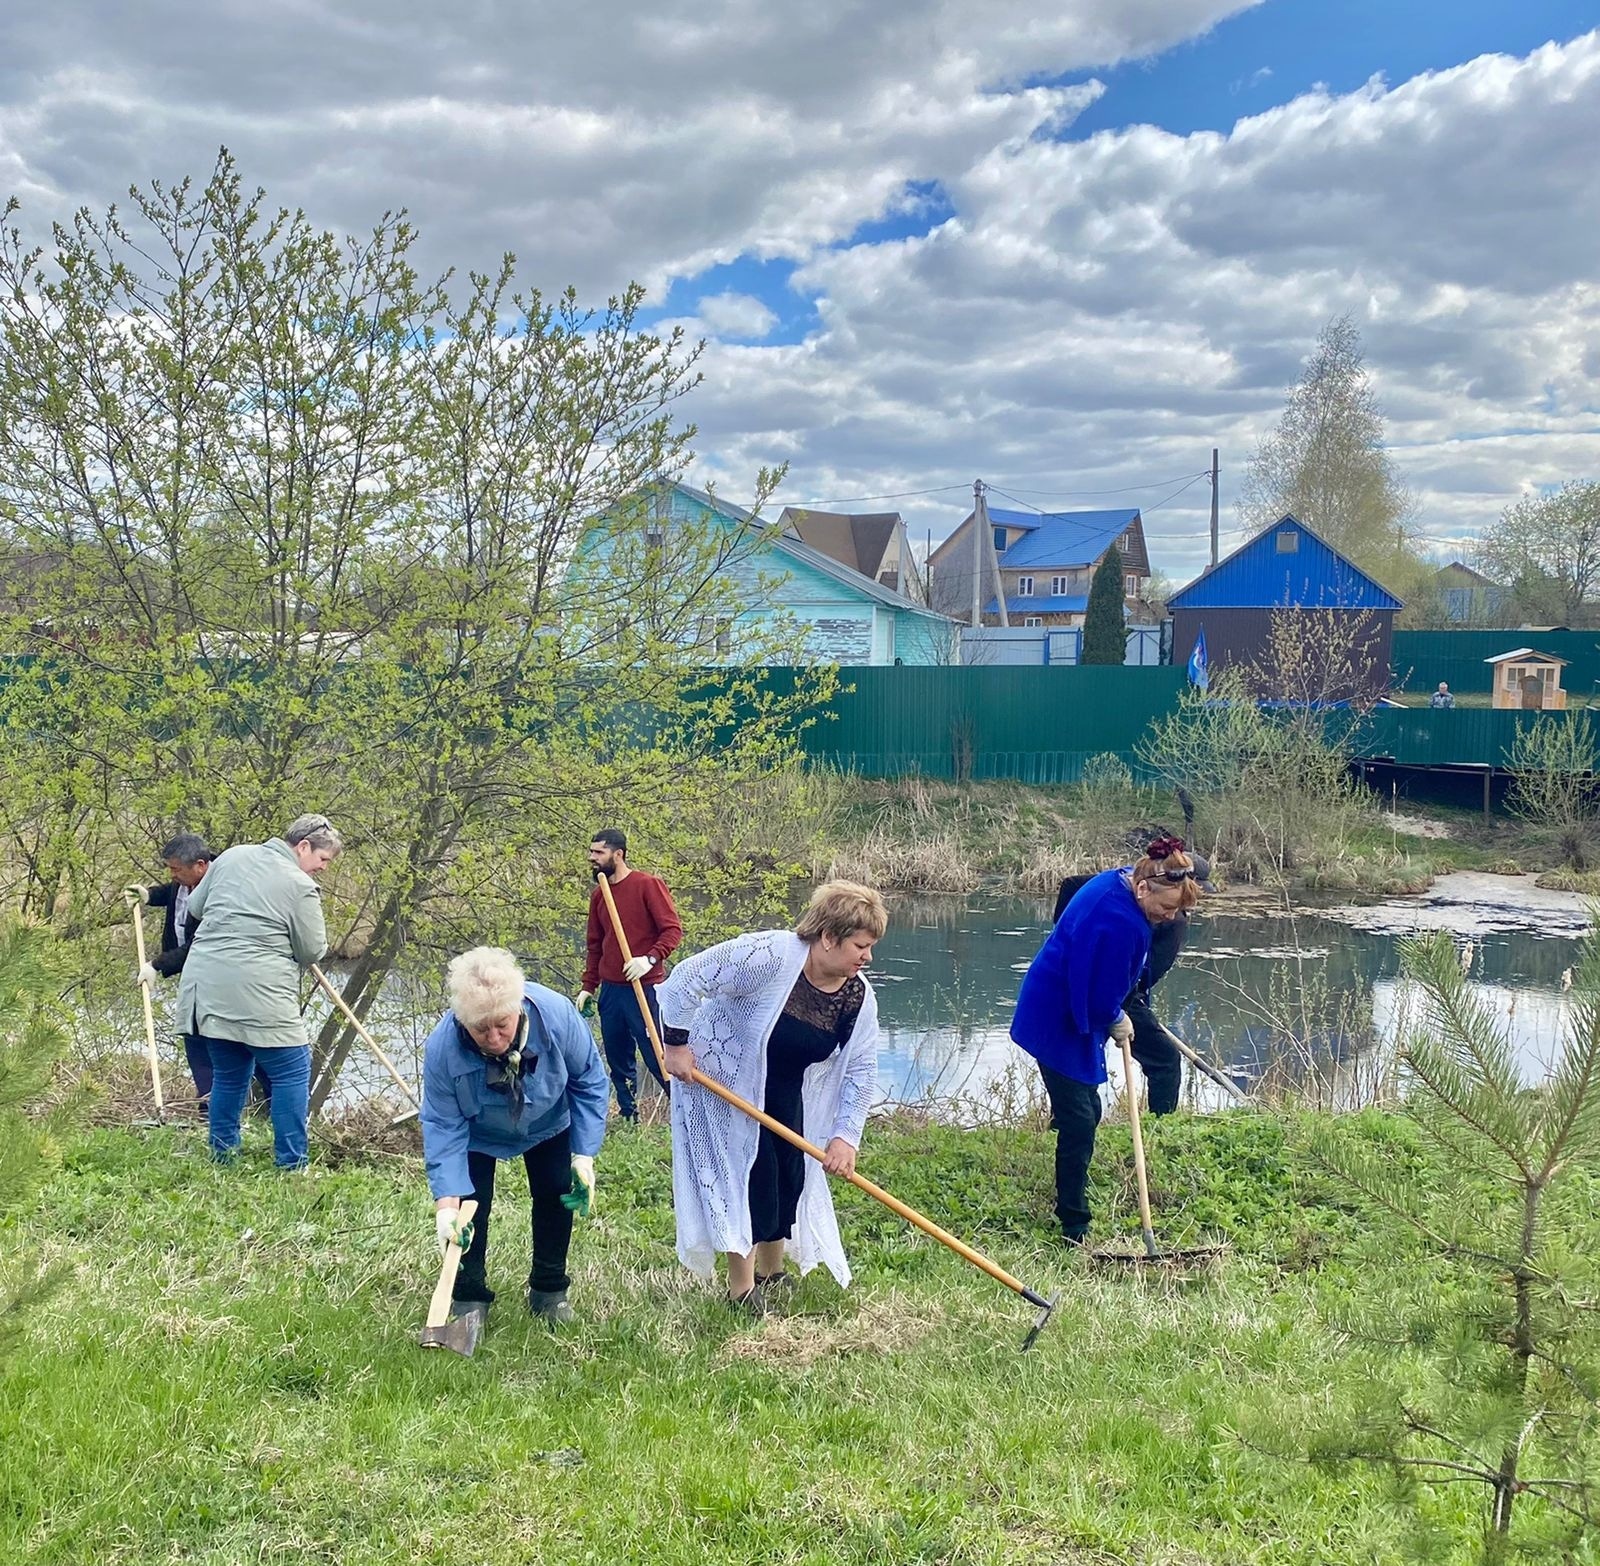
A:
1011;838;1200;1244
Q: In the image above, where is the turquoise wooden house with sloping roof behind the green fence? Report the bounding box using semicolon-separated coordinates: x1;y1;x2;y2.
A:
582;483;960;667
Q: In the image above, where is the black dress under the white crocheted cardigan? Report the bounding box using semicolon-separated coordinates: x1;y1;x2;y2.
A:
750;974;867;1244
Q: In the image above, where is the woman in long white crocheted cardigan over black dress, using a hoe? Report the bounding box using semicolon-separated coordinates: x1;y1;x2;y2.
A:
656;881;888;1315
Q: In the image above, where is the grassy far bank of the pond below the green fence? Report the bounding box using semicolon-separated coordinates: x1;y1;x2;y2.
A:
814;777;1516;894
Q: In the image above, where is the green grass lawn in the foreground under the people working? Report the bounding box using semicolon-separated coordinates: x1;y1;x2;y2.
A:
0;1112;1523;1566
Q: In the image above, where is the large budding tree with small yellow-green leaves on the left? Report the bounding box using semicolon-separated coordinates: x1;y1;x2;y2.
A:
0;152;832;1093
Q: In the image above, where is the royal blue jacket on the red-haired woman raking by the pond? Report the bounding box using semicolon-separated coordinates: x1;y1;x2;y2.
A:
1011;870;1150;1083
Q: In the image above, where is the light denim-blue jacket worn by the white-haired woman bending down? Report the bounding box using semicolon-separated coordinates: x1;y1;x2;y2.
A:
422;984;611;1201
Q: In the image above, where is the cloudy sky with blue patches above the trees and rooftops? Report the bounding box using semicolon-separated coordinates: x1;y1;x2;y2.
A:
0;0;1600;581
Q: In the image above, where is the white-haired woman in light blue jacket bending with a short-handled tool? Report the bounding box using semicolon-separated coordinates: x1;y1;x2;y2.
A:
422;945;611;1321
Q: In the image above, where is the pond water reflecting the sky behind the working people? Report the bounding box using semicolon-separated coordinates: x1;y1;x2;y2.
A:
315;875;1587;1113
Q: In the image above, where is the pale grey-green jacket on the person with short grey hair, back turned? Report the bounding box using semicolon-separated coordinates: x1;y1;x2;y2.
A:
178;838;328;1049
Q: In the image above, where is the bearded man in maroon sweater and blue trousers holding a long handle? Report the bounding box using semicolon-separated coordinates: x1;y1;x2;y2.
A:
576;827;683;1120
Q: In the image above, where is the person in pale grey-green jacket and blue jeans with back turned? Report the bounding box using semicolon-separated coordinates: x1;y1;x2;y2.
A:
178;816;344;1169
